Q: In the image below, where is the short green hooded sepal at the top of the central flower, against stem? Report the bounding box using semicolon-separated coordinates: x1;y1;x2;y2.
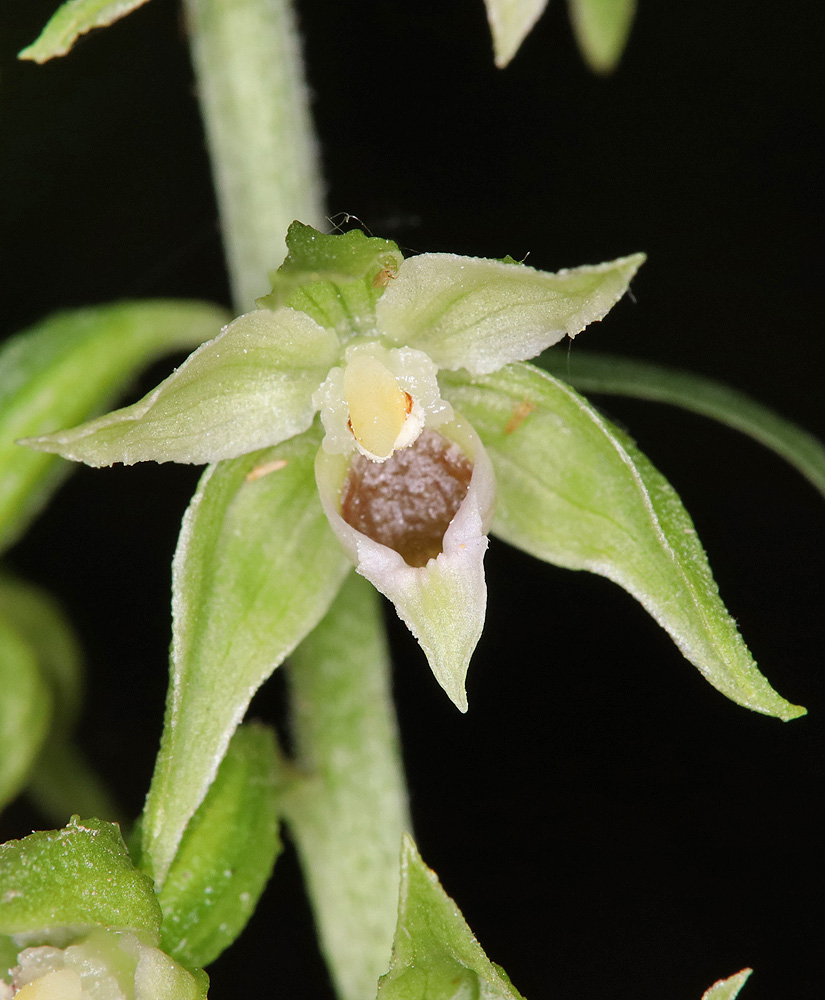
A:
257;222;403;341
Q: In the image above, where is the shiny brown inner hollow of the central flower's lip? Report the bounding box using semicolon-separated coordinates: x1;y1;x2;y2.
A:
341;430;473;566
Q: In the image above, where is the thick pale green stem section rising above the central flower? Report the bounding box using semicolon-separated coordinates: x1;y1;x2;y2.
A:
185;0;323;311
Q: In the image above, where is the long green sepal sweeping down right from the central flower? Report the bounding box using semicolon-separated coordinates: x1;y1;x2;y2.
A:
445;364;805;720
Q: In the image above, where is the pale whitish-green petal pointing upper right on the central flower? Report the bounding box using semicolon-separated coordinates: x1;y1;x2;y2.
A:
376;254;645;375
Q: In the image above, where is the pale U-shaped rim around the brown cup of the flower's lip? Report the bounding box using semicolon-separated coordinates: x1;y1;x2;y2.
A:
315;414;495;572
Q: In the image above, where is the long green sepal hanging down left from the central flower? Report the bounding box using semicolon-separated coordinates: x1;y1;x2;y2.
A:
143;426;350;886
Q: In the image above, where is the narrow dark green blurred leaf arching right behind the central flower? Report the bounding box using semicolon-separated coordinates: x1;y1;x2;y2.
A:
539;351;825;504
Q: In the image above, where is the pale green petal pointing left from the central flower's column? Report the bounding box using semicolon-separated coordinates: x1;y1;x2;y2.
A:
24;309;340;466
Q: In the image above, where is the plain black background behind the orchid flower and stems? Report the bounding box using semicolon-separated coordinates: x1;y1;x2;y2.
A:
0;0;825;1000
